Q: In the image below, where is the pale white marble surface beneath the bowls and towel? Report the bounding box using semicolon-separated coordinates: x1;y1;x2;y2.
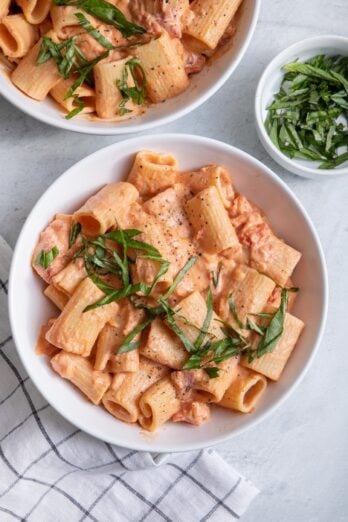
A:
0;0;348;522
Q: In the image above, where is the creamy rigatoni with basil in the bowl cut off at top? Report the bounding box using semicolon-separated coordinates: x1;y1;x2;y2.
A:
0;0;242;123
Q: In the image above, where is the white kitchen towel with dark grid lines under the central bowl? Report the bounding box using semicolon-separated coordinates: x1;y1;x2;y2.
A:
0;237;258;522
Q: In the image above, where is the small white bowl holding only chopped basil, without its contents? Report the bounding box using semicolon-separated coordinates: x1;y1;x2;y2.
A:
255;36;348;179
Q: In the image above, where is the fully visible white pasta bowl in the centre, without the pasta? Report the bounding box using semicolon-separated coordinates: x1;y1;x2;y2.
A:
9;134;328;452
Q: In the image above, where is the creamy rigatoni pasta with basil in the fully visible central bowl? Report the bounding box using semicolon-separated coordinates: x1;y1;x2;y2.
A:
32;151;304;431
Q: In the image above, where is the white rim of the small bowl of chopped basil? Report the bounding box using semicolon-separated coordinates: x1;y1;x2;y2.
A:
254;34;348;179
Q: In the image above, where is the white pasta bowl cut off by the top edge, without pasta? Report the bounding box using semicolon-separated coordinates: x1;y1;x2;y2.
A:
0;0;261;135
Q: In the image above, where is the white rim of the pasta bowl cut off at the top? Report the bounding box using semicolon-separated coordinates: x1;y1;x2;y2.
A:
0;0;261;136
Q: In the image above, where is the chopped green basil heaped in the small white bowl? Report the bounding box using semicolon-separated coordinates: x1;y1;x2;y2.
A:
265;55;348;169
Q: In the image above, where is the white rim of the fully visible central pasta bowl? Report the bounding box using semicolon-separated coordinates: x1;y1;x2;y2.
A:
8;133;329;453
